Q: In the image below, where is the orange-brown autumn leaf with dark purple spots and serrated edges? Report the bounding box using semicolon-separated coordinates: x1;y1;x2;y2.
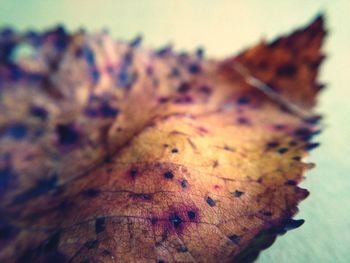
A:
0;17;324;263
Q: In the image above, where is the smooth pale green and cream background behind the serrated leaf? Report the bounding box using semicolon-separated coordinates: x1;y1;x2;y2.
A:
0;0;350;263
